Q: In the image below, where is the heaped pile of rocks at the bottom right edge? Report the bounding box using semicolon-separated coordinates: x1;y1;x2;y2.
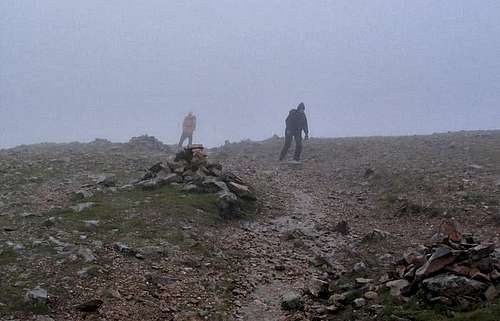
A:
386;223;500;308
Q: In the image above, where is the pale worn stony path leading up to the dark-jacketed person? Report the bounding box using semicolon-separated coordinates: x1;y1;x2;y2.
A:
214;162;356;321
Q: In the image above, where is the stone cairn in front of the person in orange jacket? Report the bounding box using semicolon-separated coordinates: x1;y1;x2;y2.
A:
134;145;257;216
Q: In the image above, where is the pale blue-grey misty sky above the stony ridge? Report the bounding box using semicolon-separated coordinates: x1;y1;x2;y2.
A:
0;0;500;147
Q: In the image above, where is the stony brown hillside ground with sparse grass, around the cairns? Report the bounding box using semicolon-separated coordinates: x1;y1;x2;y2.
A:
0;131;500;321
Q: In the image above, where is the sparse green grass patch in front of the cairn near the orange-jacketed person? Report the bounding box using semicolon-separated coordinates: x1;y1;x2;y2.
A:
49;182;230;246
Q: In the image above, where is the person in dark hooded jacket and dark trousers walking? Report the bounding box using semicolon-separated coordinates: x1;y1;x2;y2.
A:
280;103;309;161
